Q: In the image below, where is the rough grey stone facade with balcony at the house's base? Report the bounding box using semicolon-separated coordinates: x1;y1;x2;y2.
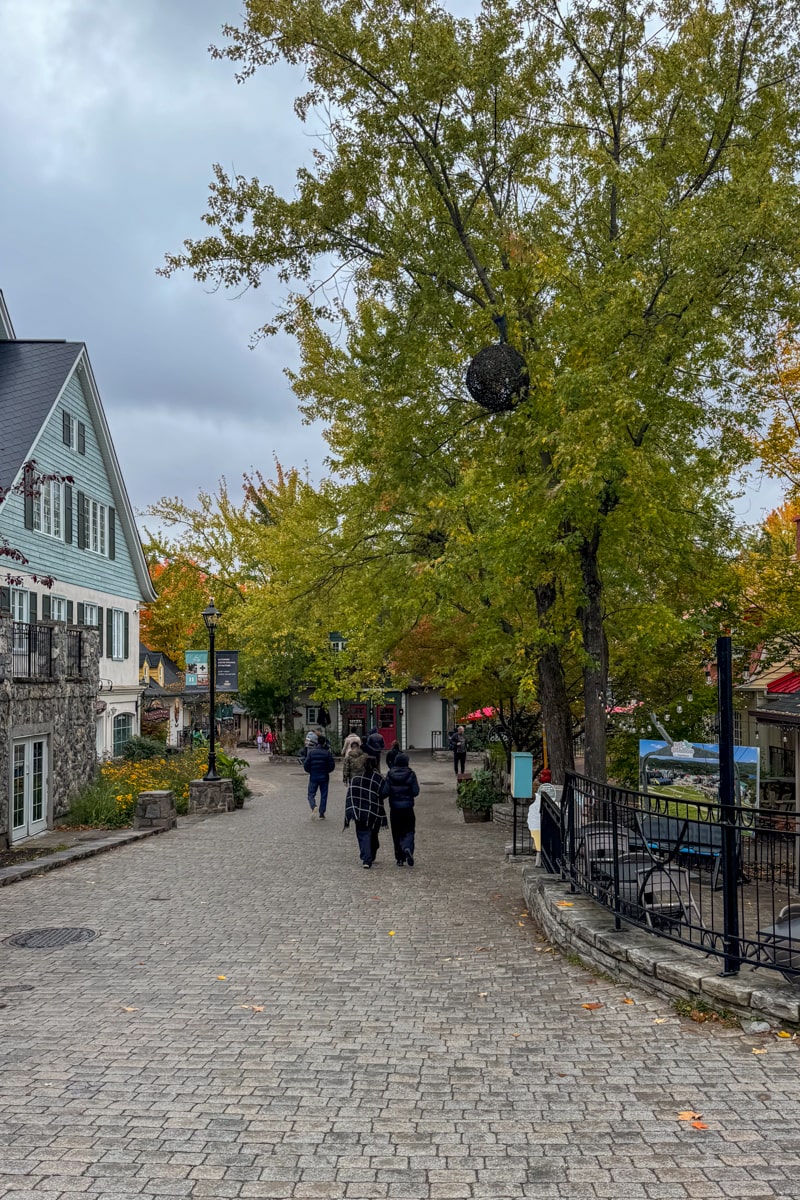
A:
0;617;100;846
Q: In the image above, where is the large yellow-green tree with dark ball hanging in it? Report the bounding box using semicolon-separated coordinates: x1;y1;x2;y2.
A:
164;0;800;778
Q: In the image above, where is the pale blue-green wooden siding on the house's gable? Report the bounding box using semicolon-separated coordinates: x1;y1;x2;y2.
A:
0;374;144;600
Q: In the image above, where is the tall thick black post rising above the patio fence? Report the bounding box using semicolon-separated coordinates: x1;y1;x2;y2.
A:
717;637;740;974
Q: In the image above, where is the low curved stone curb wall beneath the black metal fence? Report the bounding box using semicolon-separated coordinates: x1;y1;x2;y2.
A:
522;866;800;1027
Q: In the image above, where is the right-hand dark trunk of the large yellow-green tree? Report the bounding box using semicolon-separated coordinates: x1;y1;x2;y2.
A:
579;528;608;784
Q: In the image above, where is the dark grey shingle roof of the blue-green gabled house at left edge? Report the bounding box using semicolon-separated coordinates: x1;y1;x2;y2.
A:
0;341;84;488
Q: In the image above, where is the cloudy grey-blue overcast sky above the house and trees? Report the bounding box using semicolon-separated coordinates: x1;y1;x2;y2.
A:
0;0;778;521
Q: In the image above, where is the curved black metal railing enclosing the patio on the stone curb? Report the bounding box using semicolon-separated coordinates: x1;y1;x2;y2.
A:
541;774;800;979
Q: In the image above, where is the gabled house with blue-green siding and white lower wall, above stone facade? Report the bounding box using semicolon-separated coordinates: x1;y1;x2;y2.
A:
0;293;156;796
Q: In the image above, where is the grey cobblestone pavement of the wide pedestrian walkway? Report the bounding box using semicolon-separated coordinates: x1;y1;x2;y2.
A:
0;758;800;1200
